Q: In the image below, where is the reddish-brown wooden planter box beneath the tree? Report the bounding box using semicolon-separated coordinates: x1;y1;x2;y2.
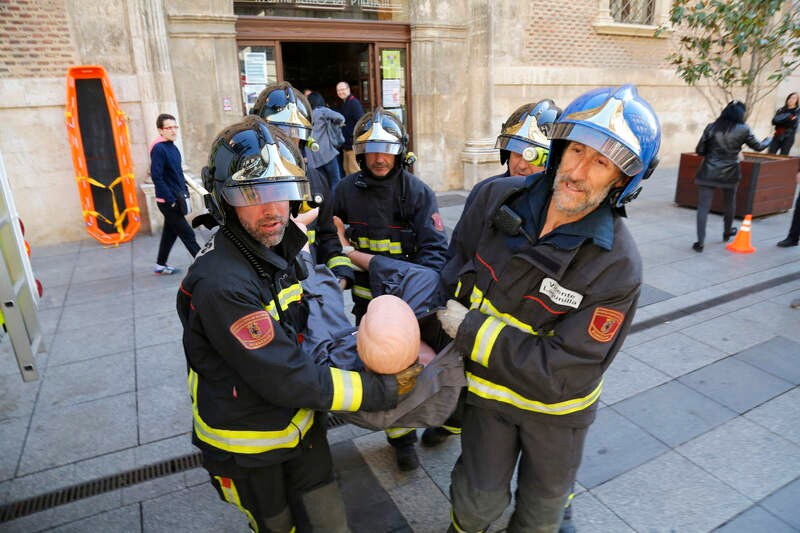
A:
675;152;800;218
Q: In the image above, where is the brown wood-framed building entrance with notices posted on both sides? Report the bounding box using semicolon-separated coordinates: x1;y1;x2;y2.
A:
236;16;413;136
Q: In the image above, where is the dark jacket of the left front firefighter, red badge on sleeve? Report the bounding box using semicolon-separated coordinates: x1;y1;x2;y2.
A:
177;223;397;466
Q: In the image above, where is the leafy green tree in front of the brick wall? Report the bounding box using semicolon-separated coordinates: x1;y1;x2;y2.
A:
659;0;800;119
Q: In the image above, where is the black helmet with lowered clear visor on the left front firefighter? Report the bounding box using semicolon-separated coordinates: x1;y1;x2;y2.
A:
203;115;310;225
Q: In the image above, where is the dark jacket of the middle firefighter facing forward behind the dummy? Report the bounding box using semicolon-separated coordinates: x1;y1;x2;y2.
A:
333;170;447;317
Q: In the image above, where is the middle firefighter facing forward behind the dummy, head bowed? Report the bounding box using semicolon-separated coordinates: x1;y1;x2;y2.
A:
333;107;447;471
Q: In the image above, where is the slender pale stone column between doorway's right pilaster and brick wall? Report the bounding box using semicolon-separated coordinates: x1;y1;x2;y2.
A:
461;0;498;189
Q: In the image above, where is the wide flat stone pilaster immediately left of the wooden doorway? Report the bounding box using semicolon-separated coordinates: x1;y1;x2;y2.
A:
164;0;242;175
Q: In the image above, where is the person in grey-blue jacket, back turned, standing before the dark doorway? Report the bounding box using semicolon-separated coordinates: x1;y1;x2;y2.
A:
306;92;344;190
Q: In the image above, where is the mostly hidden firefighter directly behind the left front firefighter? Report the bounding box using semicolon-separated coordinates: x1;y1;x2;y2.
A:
251;81;353;289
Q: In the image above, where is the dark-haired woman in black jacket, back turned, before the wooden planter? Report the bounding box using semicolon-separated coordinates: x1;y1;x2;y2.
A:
692;100;770;252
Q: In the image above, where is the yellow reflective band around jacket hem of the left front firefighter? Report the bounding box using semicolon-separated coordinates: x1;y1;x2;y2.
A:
188;369;314;454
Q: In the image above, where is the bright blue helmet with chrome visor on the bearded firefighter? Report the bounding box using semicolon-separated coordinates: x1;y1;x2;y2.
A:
547;85;661;208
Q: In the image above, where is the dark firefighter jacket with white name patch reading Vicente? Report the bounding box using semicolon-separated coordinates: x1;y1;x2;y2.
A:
442;173;642;427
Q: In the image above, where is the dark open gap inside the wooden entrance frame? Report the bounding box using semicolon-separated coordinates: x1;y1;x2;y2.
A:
281;43;372;110
